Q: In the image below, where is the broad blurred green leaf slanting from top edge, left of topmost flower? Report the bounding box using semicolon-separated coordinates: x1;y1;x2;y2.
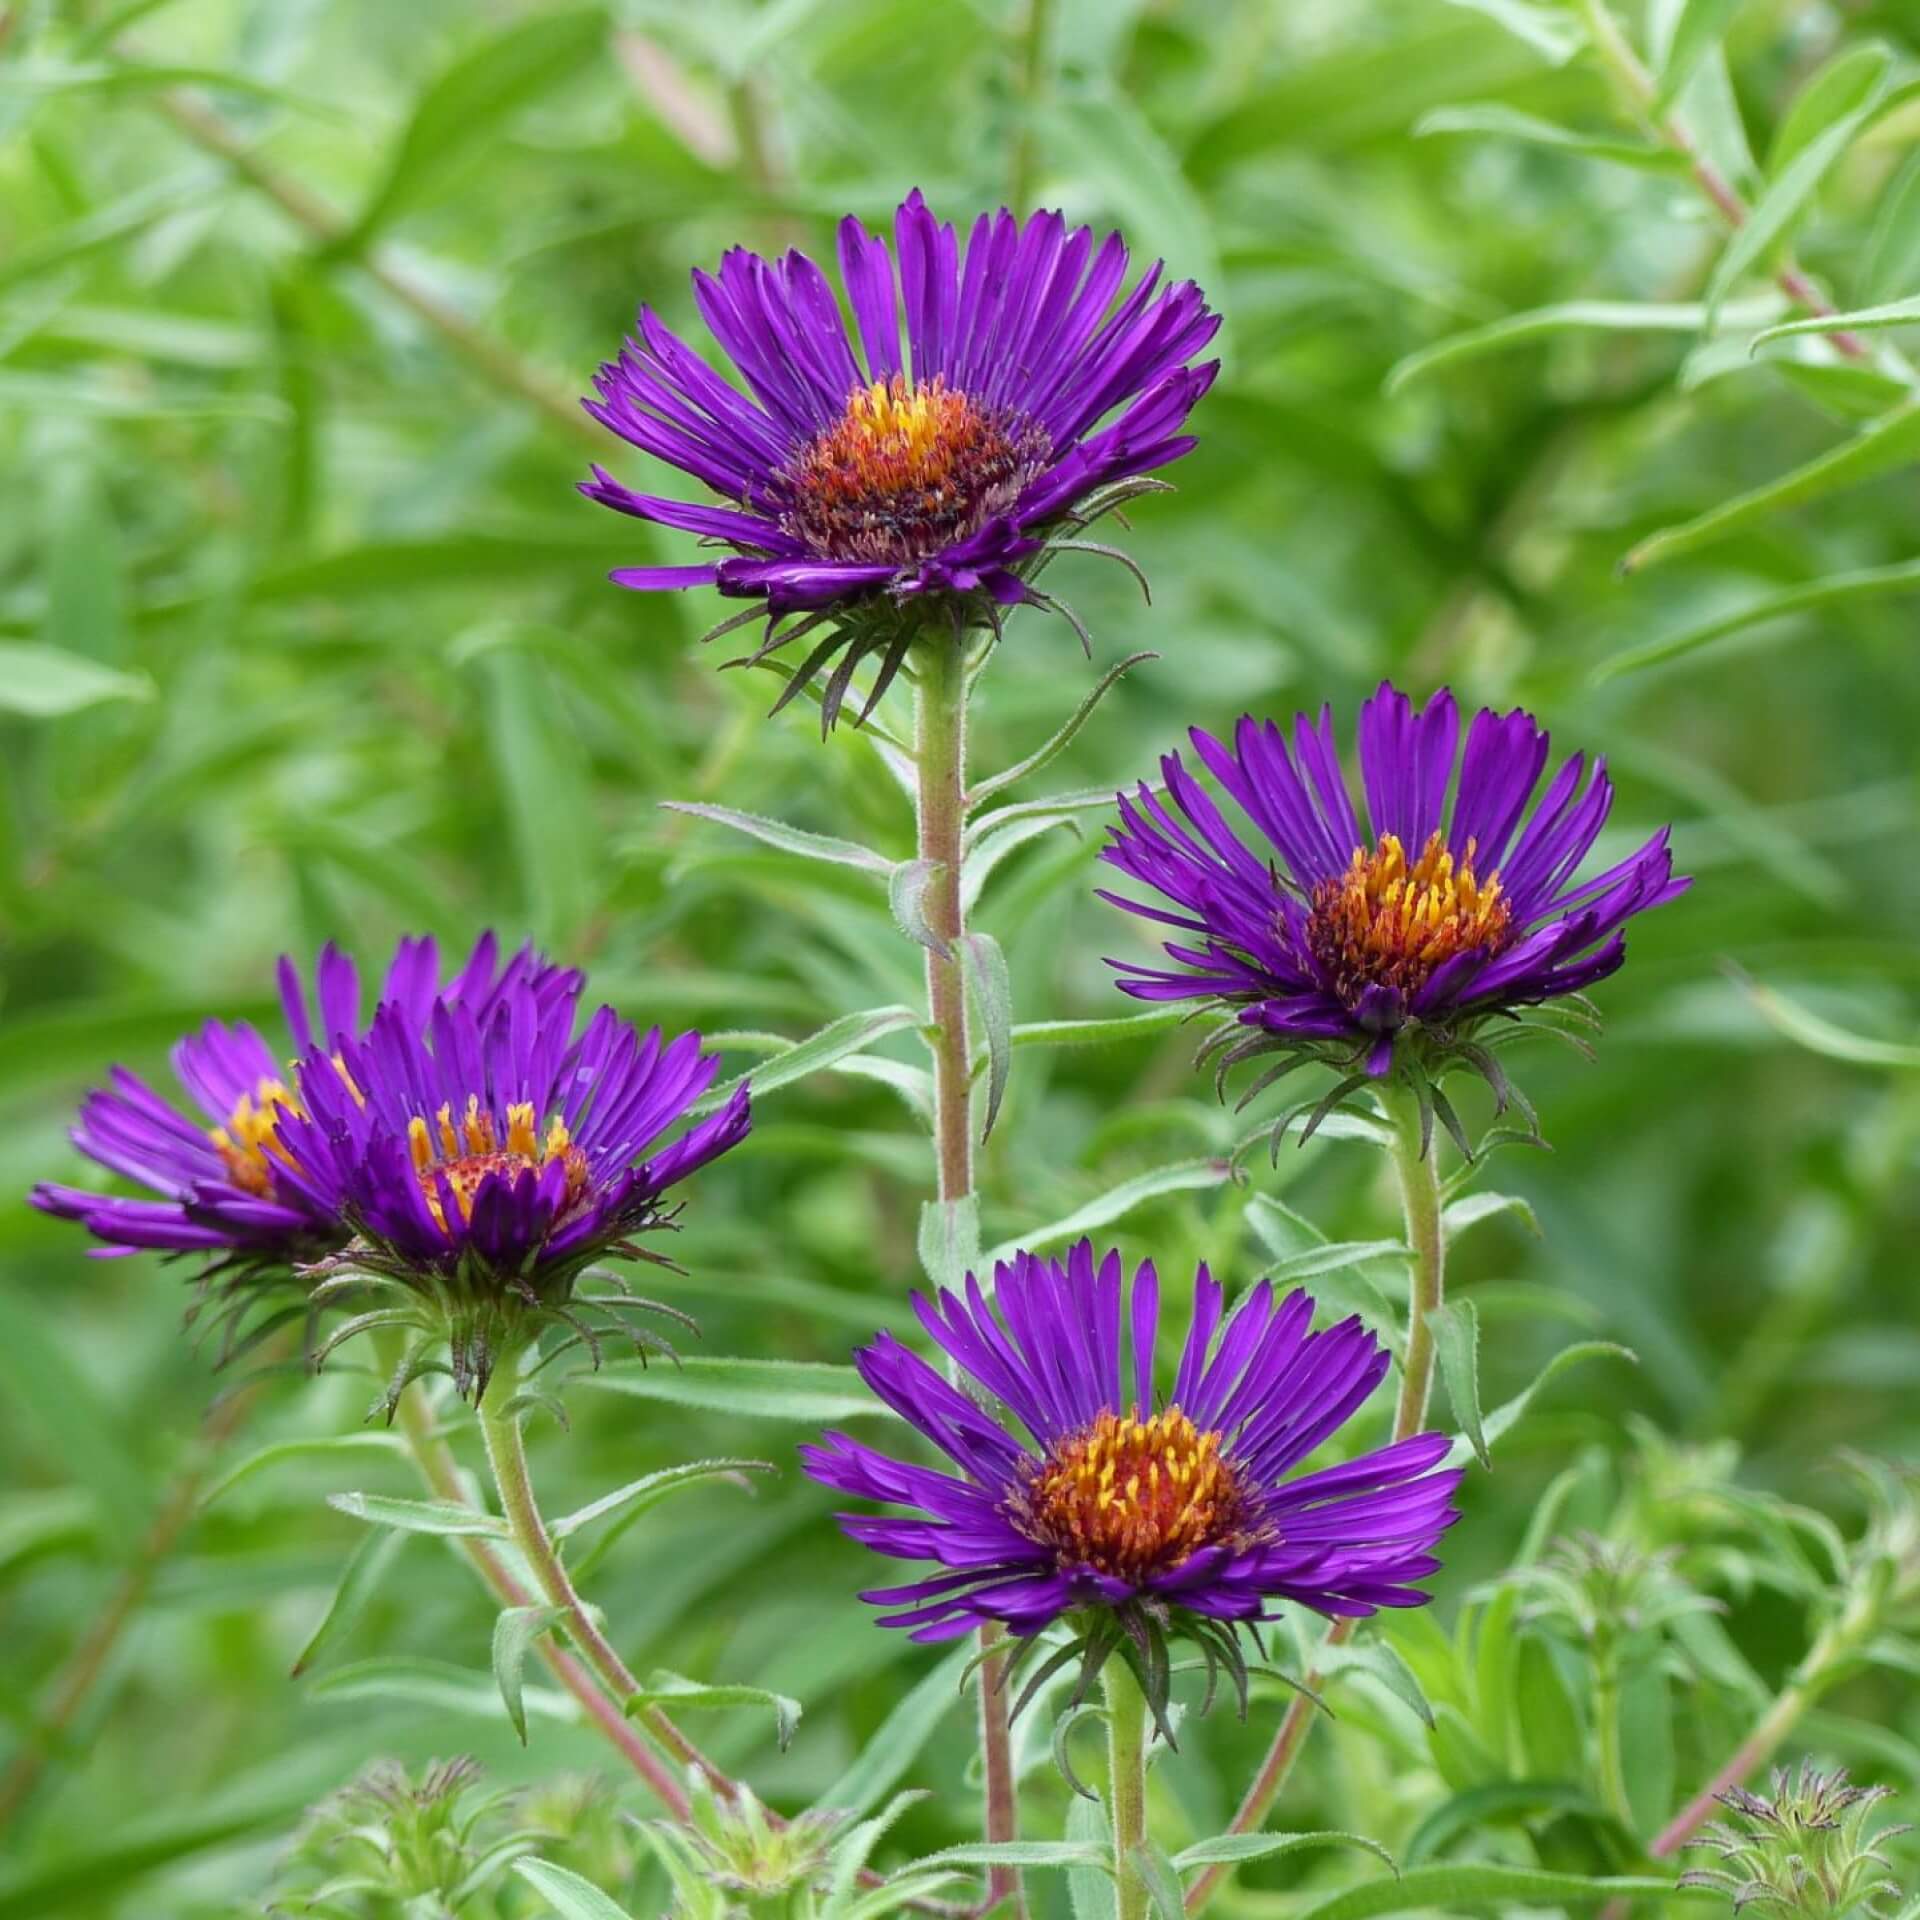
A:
338;8;607;252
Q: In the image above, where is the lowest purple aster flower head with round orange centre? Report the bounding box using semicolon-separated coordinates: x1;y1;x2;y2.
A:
801;1240;1459;1711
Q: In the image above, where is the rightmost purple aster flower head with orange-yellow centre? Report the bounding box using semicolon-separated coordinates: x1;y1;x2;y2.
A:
1100;684;1690;1125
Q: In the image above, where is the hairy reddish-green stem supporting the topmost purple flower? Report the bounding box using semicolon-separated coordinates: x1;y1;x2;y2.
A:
914;628;1025;1920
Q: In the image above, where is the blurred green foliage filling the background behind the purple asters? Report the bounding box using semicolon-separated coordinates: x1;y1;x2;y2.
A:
0;0;1920;1920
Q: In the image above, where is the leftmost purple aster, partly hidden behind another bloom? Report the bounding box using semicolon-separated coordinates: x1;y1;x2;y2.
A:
29;933;580;1359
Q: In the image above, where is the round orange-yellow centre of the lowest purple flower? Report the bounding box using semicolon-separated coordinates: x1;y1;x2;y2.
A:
1010;1407;1263;1580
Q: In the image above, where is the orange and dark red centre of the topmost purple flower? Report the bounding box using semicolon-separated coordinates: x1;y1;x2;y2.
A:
781;374;1050;563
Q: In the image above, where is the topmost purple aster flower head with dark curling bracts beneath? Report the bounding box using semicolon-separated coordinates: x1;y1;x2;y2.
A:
582;192;1219;724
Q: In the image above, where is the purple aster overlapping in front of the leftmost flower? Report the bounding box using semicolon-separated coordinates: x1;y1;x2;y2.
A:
280;979;749;1405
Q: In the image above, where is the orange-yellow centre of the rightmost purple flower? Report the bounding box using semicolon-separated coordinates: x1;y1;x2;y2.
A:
1308;831;1511;1004
